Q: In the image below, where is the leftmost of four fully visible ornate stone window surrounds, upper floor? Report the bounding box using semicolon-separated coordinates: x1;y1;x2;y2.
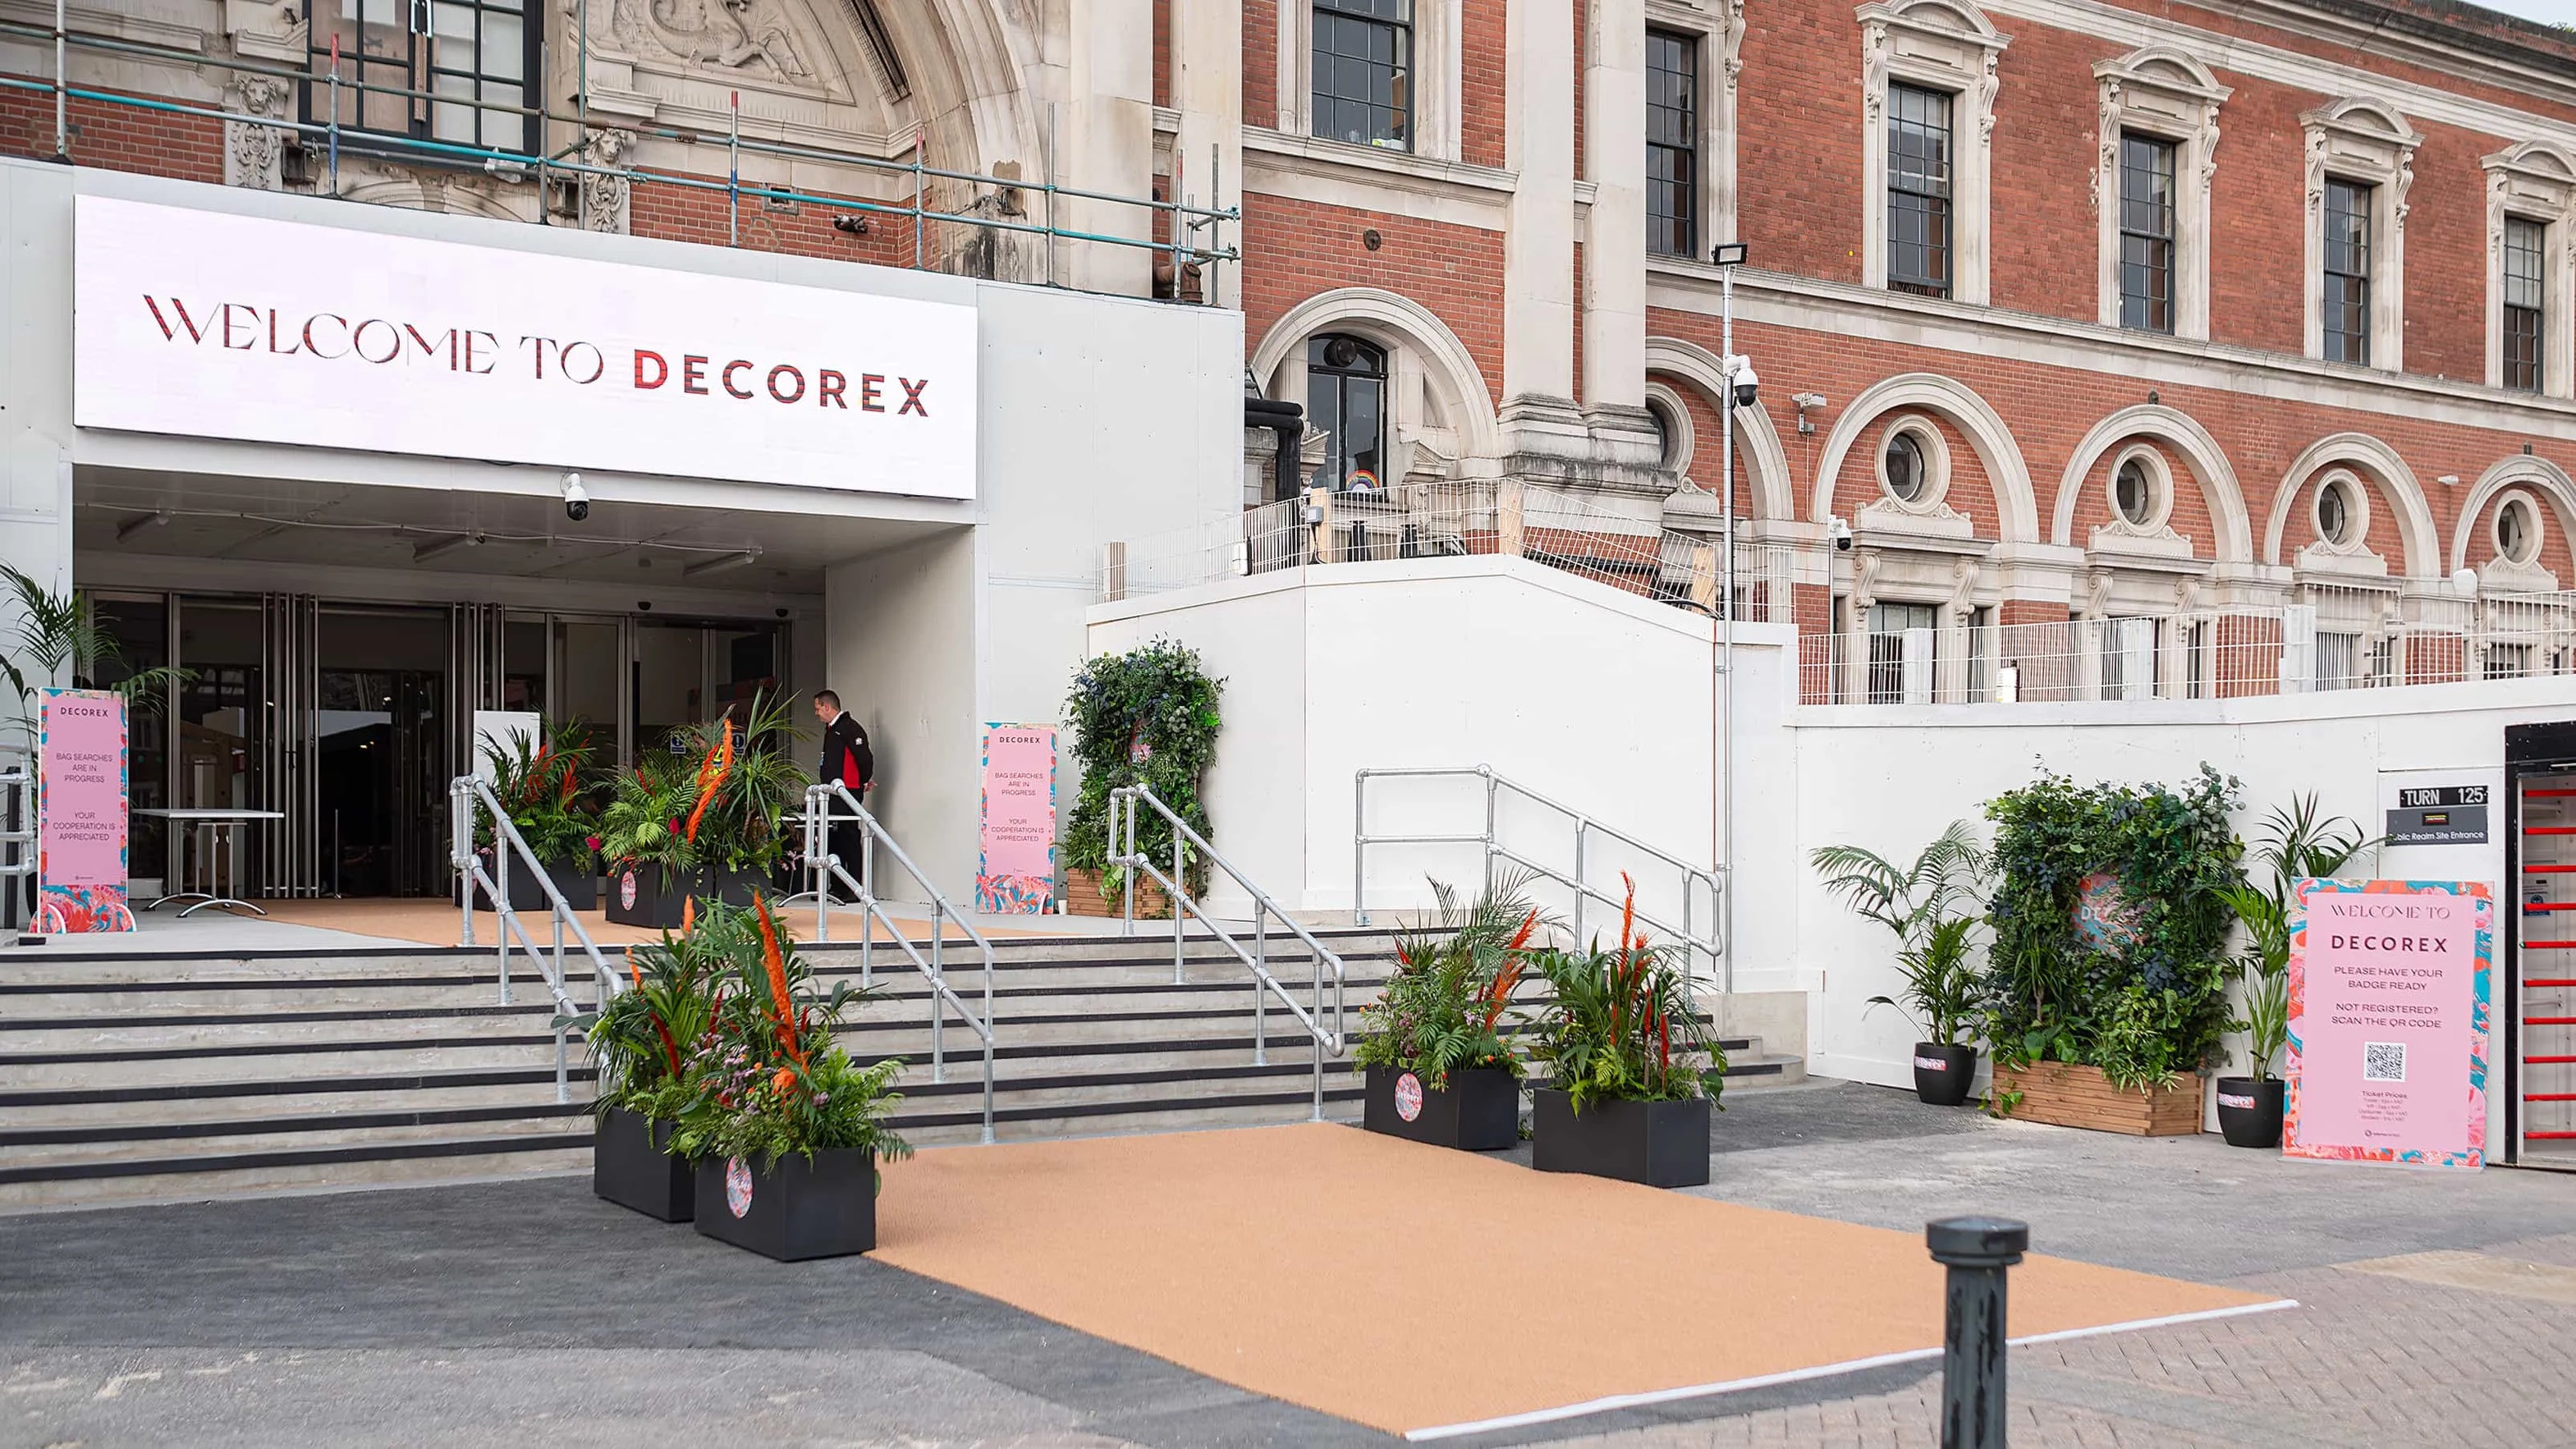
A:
1857;0;2012;307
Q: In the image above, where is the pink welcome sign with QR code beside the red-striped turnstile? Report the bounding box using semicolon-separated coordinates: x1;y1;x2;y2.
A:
2282;879;2496;1168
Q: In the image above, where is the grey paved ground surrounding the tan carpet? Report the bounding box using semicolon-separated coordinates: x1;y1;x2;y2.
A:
0;1085;2576;1449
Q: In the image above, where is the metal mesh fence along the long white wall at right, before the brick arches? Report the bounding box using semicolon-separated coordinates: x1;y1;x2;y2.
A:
1798;590;2576;704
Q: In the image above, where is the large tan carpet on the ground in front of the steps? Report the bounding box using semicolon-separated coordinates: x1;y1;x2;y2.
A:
876;1124;2288;1438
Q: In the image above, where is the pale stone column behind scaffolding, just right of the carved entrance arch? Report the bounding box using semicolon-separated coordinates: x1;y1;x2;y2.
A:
1059;0;1153;296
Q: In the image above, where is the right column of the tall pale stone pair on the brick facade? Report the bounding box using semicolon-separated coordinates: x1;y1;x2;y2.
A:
1584;0;1651;417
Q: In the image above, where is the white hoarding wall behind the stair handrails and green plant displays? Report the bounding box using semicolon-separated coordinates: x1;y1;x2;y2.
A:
1089;548;2576;1085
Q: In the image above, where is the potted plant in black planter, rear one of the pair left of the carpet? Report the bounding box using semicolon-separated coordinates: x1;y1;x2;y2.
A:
557;918;740;1222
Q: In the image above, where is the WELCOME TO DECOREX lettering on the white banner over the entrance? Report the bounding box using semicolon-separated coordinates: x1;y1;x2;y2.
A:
144;294;930;418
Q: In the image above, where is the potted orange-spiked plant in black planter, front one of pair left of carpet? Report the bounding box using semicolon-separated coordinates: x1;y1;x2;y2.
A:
670;897;912;1263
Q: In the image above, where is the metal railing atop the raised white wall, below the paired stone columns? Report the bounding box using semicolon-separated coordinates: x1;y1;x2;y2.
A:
1110;479;1829;624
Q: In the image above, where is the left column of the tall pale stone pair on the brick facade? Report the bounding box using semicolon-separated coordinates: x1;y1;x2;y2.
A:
1501;5;1589;477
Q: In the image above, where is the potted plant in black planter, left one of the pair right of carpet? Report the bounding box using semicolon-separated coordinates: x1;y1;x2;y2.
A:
1352;882;1538;1153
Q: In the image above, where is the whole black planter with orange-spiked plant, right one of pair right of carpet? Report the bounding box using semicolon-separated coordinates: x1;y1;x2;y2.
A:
1530;884;1726;1189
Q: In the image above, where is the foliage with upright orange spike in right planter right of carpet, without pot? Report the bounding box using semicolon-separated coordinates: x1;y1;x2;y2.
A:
1530;877;1726;1117
